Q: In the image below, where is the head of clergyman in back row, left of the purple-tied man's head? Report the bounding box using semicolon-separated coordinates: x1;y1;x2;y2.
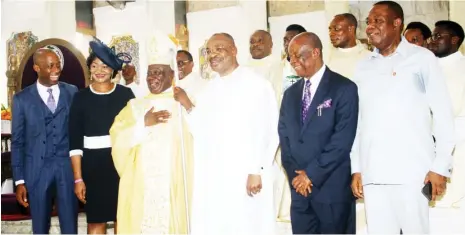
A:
249;30;273;59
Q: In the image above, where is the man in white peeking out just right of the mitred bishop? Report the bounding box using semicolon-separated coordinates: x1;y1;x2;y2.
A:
176;50;207;100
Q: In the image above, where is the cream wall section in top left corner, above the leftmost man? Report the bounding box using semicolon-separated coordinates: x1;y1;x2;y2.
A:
0;0;76;104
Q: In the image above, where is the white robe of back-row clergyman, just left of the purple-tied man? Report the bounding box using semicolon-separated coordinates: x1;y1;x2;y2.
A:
247;55;295;221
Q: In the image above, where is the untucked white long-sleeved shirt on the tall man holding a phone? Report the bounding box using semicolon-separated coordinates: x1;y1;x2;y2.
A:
351;38;455;185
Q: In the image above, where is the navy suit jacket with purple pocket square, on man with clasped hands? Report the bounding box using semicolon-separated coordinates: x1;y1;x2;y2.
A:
278;67;358;203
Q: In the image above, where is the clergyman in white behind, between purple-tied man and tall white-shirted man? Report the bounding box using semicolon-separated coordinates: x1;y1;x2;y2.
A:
328;13;370;79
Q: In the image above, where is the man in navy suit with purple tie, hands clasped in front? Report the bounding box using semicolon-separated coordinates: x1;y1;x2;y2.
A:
279;33;358;234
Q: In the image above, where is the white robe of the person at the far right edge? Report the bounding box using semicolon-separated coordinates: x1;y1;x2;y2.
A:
436;52;465;207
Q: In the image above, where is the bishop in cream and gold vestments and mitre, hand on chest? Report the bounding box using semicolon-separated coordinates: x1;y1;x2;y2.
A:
110;33;193;234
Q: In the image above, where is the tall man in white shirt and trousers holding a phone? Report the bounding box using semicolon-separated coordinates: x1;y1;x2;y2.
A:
351;1;455;234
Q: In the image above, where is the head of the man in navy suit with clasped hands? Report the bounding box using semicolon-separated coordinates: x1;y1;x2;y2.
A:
289;32;323;78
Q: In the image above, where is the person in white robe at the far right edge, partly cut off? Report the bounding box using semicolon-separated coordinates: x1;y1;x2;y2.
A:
430;20;465;207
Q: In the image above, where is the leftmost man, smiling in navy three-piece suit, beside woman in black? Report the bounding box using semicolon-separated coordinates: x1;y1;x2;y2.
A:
11;46;78;234
